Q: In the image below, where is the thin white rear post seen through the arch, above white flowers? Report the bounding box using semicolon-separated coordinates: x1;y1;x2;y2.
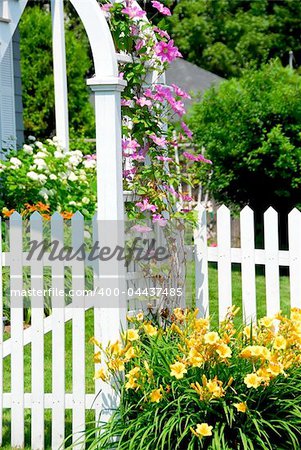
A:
51;0;68;149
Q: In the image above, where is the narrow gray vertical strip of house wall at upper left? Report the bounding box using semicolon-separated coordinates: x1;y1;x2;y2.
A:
13;28;24;147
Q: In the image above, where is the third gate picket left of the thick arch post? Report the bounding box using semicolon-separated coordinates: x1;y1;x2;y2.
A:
30;212;44;450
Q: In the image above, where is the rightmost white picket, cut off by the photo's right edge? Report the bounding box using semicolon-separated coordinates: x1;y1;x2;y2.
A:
288;208;301;308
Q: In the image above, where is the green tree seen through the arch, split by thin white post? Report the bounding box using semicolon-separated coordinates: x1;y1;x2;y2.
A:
20;6;94;138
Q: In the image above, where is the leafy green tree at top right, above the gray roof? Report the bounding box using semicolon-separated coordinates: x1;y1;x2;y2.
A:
165;0;301;78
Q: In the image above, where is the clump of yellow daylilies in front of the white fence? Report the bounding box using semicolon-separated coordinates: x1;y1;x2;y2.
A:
87;308;301;450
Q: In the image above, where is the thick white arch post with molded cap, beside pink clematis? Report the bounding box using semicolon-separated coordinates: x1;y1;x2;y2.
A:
88;77;126;420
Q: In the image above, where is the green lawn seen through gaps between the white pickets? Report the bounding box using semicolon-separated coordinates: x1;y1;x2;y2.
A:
2;263;290;449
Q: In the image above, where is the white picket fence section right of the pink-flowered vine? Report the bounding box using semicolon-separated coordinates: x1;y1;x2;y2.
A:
195;206;301;322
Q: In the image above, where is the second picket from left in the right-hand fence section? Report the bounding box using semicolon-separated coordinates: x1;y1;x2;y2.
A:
217;205;232;321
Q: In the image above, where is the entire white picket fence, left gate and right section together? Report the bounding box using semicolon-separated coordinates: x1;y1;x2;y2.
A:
0;206;301;450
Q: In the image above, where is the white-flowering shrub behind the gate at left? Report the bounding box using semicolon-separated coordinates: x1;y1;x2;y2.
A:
0;139;96;218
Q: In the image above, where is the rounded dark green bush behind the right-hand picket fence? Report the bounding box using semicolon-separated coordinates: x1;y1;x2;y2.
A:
190;61;301;212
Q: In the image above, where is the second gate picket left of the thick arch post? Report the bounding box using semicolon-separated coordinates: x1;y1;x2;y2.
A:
51;213;65;448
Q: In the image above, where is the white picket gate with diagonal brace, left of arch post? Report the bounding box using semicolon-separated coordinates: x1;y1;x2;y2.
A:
0;213;150;450
